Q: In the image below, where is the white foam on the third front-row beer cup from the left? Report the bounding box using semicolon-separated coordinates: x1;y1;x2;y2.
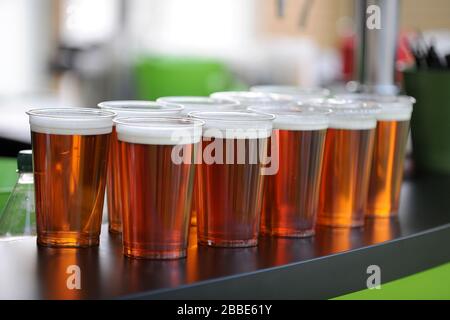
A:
189;111;275;139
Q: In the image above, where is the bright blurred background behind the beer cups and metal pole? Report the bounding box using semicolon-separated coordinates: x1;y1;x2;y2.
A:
0;0;450;156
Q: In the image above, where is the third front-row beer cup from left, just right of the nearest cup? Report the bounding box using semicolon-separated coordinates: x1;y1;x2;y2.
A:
190;111;274;247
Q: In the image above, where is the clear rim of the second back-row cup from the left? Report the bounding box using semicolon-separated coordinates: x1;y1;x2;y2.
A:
156;96;240;108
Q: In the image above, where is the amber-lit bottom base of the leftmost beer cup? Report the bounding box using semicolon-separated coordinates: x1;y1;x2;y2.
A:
37;232;100;248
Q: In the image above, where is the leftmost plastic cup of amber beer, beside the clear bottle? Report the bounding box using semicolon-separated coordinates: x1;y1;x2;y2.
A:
27;108;115;247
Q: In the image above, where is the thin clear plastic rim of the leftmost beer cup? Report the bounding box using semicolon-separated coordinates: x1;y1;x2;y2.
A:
26;107;117;121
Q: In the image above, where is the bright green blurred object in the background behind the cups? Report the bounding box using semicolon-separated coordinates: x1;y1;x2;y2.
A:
134;56;246;100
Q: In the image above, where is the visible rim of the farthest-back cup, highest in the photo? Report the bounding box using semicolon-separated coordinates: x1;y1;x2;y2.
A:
250;85;330;101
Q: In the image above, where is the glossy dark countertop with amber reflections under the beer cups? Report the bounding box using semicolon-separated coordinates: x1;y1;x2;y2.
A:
0;177;450;299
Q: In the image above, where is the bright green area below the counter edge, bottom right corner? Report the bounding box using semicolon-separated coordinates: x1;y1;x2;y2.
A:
334;263;450;300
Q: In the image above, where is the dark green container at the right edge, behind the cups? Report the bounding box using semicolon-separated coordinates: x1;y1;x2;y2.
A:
404;70;450;174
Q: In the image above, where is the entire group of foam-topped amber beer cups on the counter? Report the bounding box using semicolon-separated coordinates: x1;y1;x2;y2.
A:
28;87;414;259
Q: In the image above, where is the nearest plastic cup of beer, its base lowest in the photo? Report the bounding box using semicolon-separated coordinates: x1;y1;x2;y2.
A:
114;117;203;259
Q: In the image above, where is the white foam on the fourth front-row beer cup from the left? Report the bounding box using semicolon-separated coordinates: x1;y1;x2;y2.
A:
248;106;331;131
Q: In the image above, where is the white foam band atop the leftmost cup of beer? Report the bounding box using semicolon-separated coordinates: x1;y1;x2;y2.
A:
27;108;116;135
